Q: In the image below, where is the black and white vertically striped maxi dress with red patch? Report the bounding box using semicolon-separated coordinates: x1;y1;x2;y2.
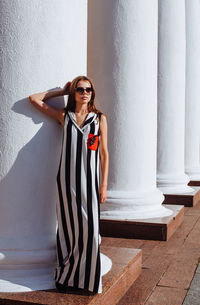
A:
55;111;102;293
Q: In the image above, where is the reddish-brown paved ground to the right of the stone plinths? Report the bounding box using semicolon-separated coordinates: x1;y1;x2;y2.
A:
101;201;200;305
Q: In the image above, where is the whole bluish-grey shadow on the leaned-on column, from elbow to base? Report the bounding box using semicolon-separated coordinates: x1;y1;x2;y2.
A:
0;90;65;290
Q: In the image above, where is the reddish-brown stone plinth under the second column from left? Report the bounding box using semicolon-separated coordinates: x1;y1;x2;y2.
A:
100;205;184;241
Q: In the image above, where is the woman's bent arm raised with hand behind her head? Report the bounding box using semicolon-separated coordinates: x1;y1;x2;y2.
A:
29;82;70;126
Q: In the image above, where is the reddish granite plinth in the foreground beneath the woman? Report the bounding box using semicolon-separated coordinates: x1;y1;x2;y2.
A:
0;245;142;305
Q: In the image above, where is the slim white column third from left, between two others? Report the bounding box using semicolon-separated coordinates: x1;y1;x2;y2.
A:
157;0;193;194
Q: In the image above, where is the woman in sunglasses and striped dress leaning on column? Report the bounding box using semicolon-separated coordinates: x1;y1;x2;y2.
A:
29;76;108;293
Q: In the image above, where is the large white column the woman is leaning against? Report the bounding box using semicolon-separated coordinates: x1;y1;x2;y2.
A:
0;0;87;292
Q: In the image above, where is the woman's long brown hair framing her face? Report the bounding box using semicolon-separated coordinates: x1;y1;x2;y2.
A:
65;76;101;114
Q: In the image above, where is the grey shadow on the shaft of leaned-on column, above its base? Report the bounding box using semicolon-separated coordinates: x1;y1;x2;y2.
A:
0;90;65;251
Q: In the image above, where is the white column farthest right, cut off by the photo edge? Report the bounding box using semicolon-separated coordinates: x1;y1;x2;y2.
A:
185;0;200;181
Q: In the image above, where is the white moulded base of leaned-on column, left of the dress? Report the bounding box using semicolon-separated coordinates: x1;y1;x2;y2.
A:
0;246;56;292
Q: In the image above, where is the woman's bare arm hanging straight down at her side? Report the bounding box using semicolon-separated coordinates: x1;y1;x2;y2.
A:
100;115;109;203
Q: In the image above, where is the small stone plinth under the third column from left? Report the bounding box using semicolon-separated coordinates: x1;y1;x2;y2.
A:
163;187;200;207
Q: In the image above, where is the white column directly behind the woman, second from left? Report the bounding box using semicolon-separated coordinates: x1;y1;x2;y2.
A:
88;0;171;219
